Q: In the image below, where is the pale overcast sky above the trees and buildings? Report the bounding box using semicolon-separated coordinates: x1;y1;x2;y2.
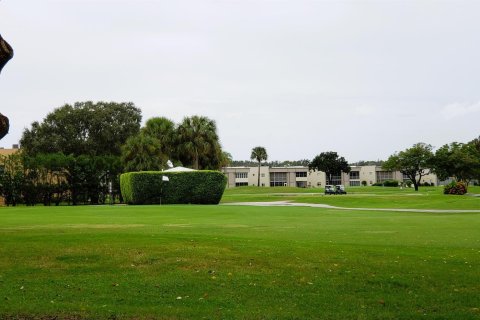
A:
0;0;480;162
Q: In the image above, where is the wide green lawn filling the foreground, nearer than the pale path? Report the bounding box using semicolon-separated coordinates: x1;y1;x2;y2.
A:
0;200;480;319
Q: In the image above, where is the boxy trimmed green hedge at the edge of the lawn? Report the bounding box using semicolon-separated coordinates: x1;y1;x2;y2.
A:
120;170;227;204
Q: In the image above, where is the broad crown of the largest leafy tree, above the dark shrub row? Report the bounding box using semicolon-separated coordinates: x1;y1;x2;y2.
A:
20;101;141;156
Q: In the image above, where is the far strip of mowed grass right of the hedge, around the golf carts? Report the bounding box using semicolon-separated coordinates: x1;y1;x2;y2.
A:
222;186;480;210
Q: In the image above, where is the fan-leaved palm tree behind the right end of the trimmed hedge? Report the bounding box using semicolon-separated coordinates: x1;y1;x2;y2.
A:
177;116;220;170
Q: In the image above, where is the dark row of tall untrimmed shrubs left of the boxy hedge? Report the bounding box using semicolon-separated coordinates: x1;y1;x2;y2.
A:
0;152;121;206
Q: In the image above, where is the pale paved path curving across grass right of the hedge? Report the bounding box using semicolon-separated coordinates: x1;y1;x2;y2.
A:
222;201;480;213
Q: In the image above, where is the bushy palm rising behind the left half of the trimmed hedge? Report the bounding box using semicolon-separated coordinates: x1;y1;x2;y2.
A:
122;133;168;172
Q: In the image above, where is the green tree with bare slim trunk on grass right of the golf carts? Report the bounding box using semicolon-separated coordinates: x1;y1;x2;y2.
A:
382;142;433;191
